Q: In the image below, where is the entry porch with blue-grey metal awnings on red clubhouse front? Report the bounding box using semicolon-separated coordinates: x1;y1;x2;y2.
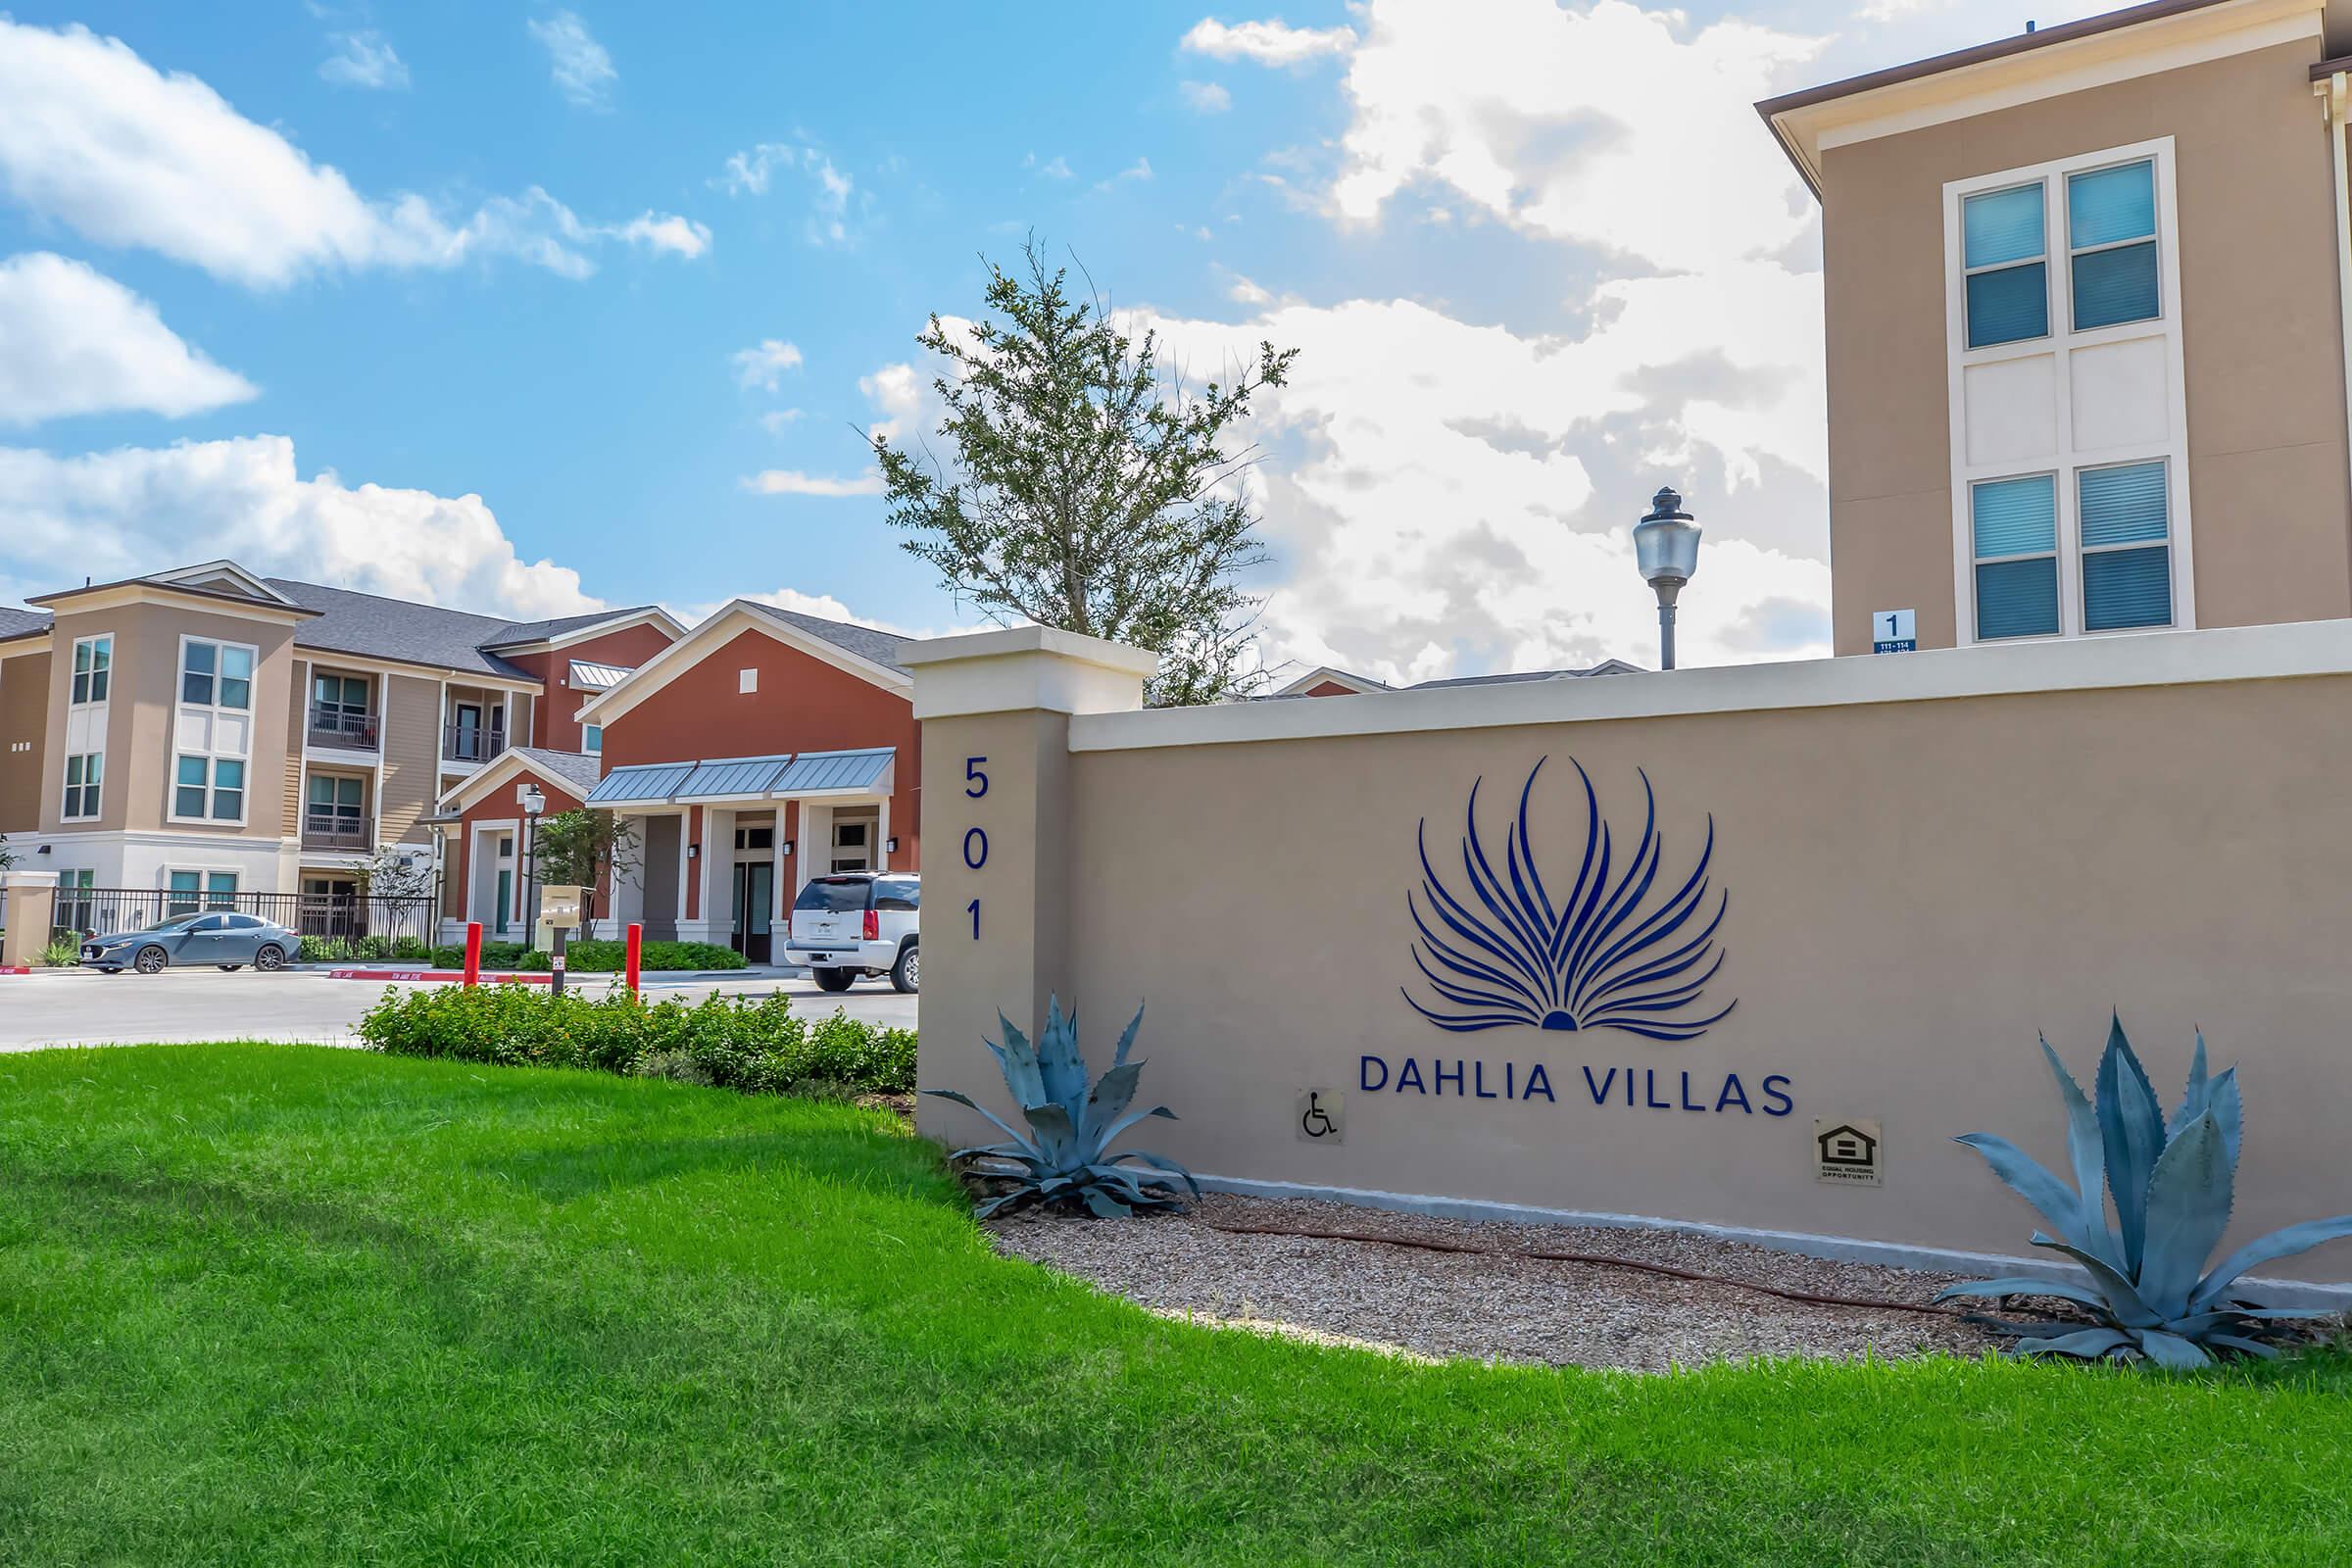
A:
588;748;899;964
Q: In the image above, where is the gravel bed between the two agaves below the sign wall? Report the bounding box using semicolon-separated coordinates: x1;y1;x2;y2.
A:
993;1195;1994;1373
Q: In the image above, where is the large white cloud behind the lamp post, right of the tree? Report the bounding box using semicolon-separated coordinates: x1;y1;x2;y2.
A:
1138;291;1830;679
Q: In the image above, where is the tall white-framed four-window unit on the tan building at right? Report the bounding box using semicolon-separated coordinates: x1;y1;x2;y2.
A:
1945;136;2197;644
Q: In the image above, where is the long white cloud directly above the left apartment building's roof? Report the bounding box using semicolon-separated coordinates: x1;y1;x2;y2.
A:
0;435;605;618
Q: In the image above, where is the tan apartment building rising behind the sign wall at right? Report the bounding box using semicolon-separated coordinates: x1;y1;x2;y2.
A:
1757;0;2352;654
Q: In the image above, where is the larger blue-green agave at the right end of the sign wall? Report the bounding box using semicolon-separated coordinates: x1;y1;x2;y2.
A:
1936;1018;2352;1368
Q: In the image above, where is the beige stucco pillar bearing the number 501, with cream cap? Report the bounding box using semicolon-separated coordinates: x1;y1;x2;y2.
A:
901;625;1159;1138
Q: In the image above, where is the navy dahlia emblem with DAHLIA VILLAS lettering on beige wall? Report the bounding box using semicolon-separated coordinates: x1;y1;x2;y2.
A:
1357;757;1794;1116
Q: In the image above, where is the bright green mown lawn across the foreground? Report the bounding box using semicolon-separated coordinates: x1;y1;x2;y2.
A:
0;1046;2352;1568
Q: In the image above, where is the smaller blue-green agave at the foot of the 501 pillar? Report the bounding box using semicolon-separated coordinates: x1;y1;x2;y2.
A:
922;997;1200;1220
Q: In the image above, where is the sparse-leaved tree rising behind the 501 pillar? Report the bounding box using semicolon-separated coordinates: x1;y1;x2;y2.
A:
870;240;1298;706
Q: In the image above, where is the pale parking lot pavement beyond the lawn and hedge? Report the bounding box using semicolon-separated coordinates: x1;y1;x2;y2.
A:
0;968;917;1051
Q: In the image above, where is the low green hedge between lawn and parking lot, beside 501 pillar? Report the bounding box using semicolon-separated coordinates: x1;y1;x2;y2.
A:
360;985;915;1093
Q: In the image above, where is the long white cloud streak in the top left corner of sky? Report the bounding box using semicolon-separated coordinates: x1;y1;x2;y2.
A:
0;17;708;289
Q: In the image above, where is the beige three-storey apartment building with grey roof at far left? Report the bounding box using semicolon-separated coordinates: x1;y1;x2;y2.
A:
0;562;682;924
